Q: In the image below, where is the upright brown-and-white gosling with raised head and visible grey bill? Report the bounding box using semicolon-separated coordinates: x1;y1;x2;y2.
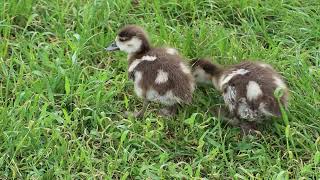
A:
106;25;194;117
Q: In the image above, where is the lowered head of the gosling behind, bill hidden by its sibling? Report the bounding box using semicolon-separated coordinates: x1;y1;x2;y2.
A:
191;59;222;87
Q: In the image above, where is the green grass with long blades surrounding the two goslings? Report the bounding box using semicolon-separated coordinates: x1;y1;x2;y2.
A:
0;0;320;179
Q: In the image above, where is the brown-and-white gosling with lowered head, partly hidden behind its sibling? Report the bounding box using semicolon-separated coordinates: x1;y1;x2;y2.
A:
191;59;288;132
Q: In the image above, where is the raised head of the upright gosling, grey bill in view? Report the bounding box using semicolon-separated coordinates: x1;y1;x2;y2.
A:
106;25;150;54
